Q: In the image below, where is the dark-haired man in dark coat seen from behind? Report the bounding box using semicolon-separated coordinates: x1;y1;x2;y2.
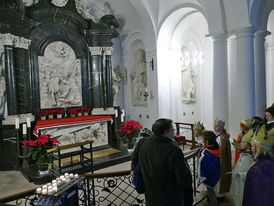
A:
138;119;192;206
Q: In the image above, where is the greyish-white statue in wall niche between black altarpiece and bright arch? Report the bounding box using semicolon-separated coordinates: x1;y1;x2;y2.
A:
130;48;147;106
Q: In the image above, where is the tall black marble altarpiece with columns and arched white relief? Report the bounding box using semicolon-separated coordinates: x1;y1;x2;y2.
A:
0;0;121;171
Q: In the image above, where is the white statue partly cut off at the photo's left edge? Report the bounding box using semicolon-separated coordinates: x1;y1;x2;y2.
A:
0;52;6;114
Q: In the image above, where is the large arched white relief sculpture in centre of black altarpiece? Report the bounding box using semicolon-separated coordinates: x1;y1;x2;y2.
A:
38;41;82;109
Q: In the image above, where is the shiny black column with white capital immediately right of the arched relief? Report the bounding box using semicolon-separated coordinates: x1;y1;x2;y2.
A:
89;47;104;108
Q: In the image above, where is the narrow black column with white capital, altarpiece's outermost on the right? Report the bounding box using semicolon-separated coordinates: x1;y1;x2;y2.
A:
103;47;113;107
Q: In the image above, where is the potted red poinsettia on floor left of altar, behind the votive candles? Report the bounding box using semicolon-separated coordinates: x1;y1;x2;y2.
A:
22;134;60;169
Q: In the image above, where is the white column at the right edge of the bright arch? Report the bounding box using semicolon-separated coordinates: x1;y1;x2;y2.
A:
211;34;228;126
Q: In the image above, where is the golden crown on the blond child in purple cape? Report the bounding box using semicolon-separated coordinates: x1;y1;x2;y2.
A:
251;125;274;149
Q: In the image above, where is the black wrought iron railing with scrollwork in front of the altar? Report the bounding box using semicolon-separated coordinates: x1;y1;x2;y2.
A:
0;150;204;206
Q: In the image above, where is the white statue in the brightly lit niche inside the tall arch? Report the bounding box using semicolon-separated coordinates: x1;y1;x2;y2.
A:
181;47;196;104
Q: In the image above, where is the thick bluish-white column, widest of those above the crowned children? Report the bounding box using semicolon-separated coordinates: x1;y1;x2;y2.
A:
235;28;255;121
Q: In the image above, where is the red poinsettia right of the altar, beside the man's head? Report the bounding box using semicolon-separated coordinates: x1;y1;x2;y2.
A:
118;120;143;143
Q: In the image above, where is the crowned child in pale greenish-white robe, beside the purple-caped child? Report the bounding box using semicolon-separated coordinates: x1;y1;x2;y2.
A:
232;132;253;206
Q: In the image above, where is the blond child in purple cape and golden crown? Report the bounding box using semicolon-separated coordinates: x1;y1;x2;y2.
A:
243;125;274;206
